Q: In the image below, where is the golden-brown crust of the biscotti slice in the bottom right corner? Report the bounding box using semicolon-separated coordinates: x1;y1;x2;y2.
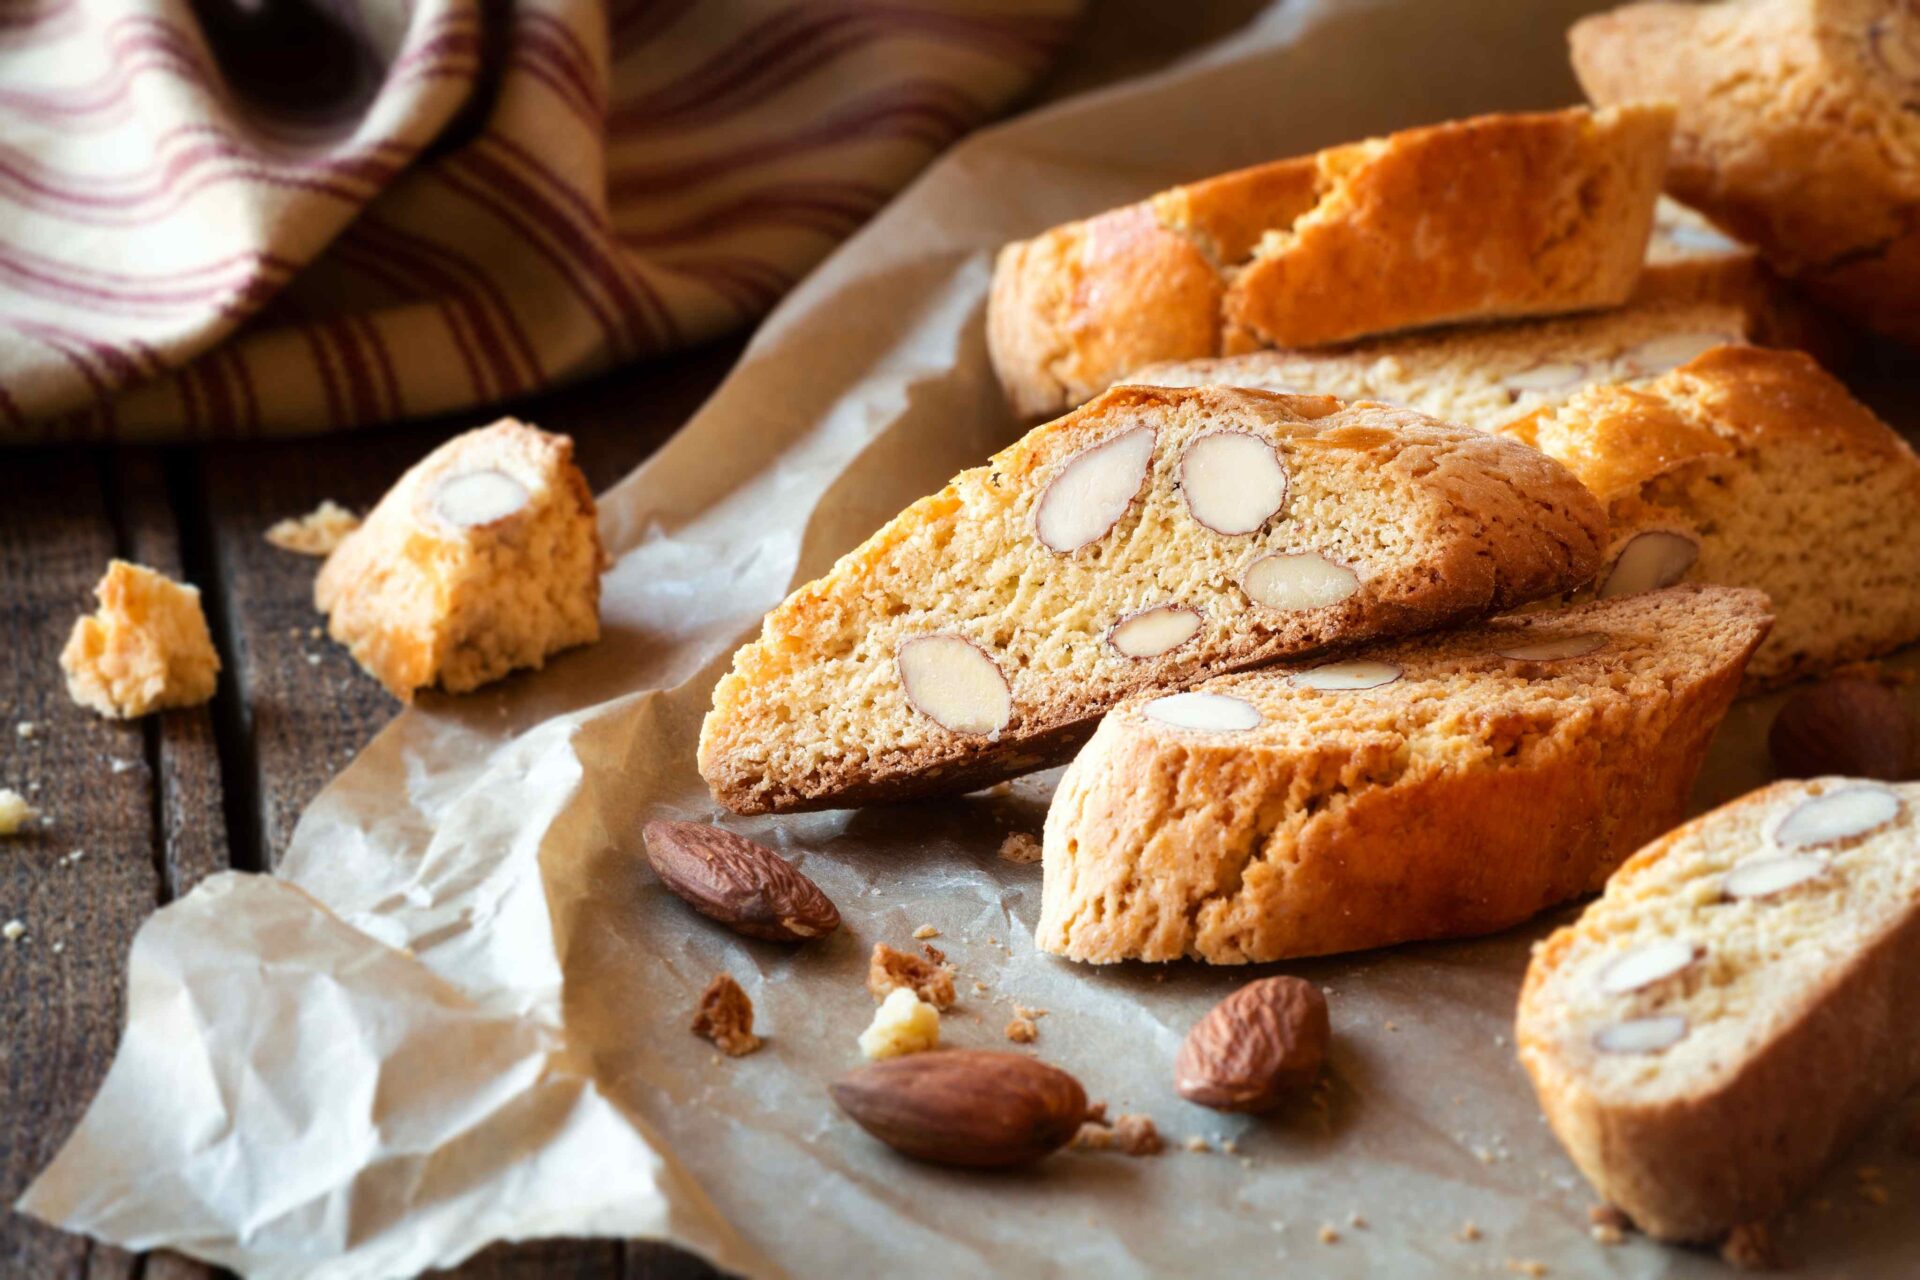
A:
1515;783;1920;1240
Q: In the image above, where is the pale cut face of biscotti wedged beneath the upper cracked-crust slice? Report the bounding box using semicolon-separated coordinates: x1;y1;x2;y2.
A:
1135;303;1751;432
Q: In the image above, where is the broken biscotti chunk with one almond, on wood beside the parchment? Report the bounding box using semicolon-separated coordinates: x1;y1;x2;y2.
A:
313;418;601;702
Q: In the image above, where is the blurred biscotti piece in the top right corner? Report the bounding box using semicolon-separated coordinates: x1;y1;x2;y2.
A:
1571;0;1920;342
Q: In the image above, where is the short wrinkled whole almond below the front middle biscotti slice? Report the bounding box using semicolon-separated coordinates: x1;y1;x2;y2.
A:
1173;977;1332;1111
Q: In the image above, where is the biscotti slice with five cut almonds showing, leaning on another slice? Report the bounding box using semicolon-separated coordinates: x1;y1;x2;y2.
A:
699;388;1599;814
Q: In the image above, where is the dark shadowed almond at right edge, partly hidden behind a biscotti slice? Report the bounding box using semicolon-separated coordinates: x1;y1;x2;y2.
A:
1766;676;1914;783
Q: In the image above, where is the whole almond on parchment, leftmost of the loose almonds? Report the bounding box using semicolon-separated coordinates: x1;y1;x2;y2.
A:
641;821;839;942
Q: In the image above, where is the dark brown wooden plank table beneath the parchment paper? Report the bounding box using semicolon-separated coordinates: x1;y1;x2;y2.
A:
0;340;741;1280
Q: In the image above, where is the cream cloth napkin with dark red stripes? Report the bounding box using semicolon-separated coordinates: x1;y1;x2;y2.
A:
0;0;1079;441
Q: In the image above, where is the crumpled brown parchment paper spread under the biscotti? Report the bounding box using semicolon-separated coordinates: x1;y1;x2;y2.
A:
23;0;1916;1278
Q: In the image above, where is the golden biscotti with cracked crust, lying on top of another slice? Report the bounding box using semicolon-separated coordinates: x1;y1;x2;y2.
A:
987;104;1672;416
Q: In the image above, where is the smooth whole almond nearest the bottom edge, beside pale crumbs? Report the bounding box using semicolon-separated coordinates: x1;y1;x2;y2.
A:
829;1050;1087;1169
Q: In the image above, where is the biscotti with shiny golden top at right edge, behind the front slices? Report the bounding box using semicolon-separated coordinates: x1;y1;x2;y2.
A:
1507;339;1920;689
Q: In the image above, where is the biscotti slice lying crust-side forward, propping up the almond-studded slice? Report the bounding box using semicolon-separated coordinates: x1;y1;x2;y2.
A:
1037;587;1768;963
